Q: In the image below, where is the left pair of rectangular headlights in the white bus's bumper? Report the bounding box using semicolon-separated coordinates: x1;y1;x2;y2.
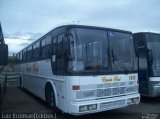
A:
79;104;97;112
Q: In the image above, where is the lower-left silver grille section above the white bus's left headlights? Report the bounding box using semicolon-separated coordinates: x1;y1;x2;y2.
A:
76;90;95;99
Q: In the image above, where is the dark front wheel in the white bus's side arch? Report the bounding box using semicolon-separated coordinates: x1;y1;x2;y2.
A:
45;84;57;112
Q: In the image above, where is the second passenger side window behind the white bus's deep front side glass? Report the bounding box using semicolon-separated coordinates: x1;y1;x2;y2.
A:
33;41;40;59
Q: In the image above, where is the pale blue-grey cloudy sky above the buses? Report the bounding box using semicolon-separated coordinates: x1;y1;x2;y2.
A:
0;0;160;53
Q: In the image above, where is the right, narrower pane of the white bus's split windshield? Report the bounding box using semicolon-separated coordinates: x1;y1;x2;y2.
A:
108;31;135;71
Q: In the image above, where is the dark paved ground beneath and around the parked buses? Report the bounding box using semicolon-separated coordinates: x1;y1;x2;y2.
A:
1;86;160;119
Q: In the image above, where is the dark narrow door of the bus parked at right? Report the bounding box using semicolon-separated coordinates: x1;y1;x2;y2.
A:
138;49;149;95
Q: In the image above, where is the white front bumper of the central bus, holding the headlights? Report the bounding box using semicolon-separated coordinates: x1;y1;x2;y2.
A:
67;93;140;115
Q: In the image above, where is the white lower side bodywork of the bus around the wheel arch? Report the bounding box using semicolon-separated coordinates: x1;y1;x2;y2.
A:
16;60;67;112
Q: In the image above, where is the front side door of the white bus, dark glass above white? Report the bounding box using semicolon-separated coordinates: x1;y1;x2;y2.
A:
51;34;68;112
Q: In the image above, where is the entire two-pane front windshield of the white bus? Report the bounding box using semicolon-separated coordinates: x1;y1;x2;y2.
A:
68;28;134;72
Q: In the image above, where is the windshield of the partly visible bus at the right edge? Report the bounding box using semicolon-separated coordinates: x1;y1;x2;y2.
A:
146;34;160;67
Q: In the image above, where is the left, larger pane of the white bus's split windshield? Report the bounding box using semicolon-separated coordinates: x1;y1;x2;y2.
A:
68;28;108;72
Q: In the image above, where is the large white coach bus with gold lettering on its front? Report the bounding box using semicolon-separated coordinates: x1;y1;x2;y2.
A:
17;25;140;115
